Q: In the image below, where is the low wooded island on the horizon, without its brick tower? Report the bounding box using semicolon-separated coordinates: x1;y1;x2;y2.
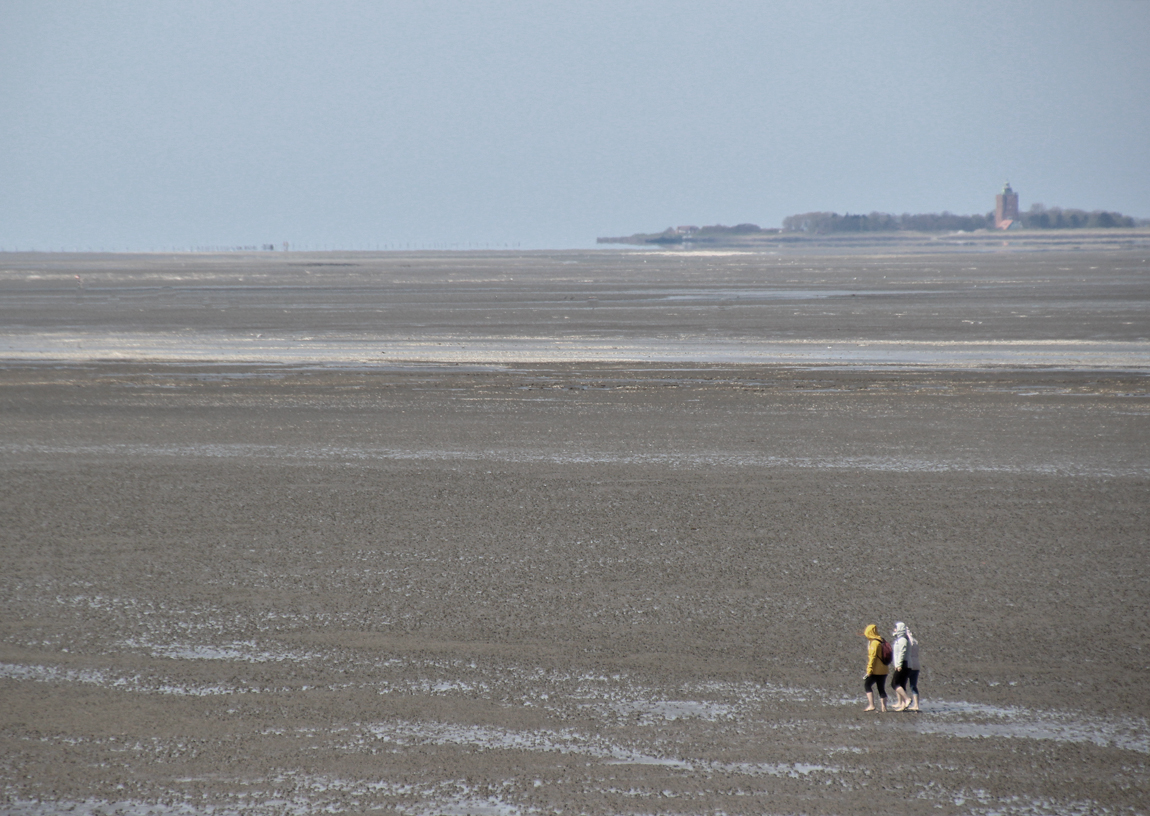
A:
596;205;1150;246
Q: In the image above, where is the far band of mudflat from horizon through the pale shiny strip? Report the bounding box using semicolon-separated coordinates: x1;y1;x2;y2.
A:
0;247;1150;369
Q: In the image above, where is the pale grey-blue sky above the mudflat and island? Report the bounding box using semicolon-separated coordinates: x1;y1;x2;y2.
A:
0;0;1150;249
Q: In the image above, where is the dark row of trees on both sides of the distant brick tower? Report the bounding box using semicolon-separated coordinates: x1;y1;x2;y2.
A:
783;205;1150;234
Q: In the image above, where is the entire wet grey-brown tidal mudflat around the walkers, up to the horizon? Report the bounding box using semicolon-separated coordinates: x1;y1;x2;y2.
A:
0;252;1150;815
